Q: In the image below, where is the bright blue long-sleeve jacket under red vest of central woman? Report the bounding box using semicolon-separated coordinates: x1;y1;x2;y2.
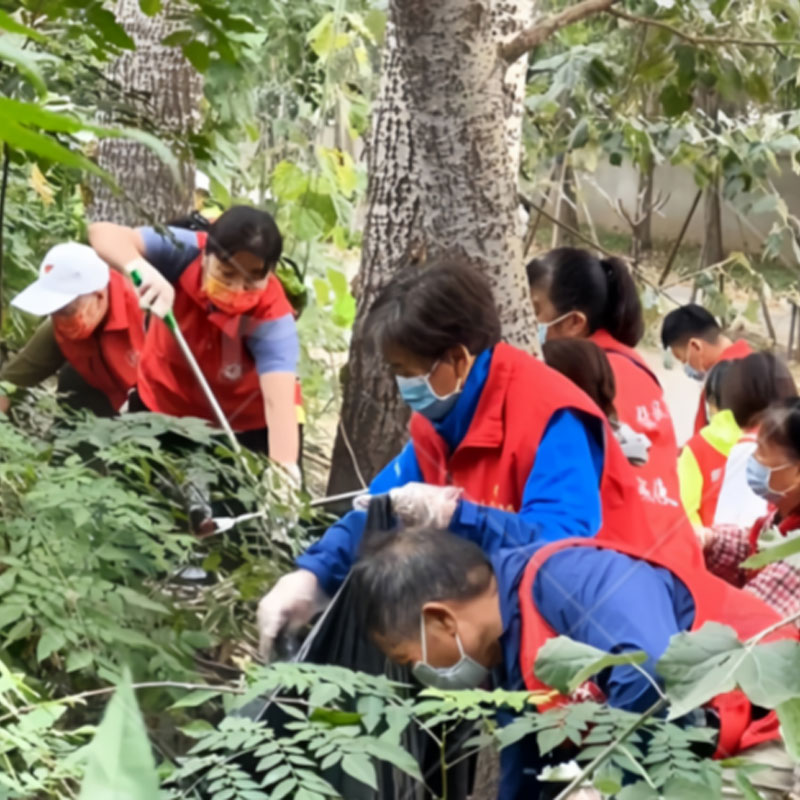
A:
296;350;603;594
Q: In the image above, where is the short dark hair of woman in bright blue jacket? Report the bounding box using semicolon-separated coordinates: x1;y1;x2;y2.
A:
364;261;500;359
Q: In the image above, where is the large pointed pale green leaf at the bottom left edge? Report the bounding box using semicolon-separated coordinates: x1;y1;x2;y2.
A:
80;668;159;800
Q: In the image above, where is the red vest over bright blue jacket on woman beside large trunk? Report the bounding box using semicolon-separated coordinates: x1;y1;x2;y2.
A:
410;343;702;563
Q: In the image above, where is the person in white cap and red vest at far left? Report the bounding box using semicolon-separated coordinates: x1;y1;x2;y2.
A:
0;242;144;416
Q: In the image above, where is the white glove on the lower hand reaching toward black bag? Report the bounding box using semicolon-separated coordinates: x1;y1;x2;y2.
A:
256;569;328;662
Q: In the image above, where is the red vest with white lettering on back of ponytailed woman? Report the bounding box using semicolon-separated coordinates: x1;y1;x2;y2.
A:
589;330;694;564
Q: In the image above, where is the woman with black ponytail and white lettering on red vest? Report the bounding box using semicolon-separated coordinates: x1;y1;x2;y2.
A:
527;247;688;537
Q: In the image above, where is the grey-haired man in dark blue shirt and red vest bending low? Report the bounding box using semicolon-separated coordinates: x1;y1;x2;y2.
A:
352;528;797;800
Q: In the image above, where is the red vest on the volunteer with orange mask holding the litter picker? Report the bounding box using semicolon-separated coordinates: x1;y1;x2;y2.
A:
138;232;292;431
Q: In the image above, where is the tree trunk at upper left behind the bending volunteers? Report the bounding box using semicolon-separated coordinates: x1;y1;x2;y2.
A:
88;0;203;225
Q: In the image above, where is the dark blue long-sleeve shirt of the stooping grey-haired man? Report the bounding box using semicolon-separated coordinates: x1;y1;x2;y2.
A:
491;545;695;800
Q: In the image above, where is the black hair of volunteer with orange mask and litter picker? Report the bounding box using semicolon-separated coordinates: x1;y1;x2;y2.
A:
206;206;283;277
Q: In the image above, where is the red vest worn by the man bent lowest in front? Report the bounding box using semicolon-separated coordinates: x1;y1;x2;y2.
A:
519;539;800;758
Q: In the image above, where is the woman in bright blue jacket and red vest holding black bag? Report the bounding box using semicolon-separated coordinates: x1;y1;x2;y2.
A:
259;262;702;655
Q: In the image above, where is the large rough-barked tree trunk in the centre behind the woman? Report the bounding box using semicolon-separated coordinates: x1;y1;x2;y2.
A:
329;0;535;492
